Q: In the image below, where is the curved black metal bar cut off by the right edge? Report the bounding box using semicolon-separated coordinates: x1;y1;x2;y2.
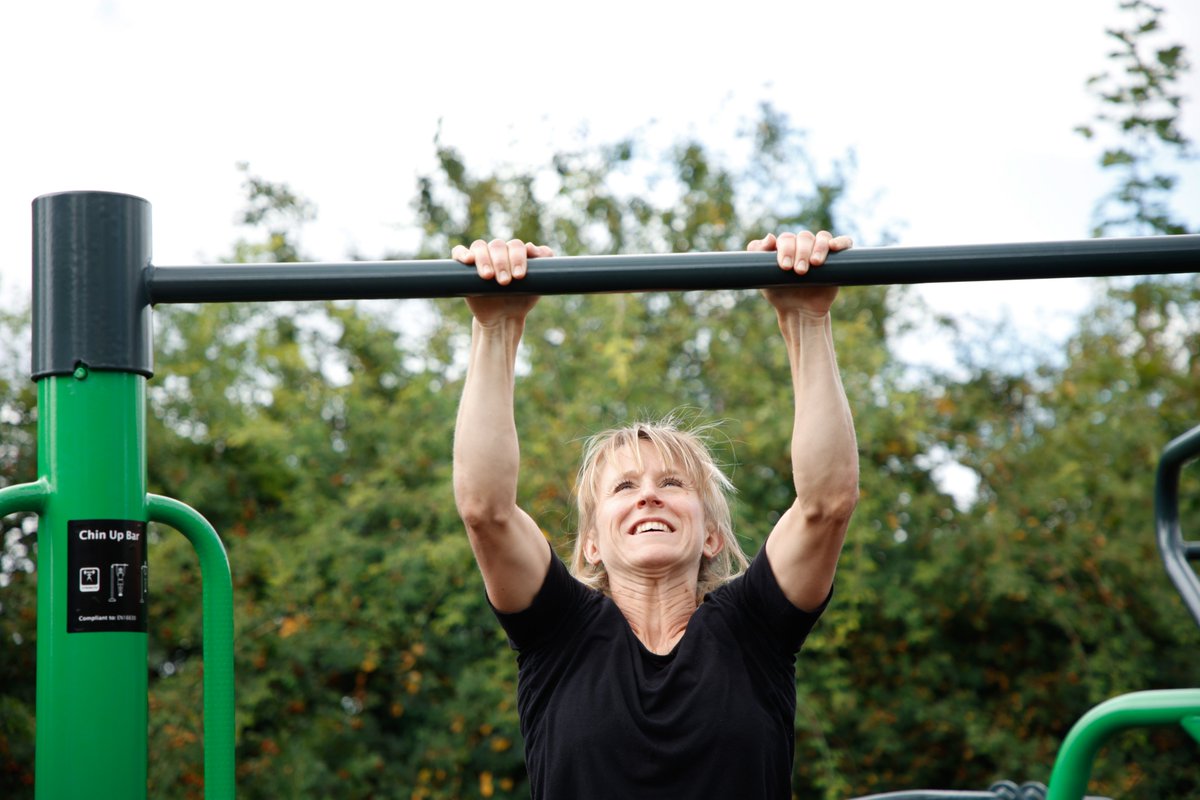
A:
1154;426;1200;625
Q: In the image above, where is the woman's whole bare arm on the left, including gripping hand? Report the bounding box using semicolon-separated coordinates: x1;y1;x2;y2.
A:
451;239;553;613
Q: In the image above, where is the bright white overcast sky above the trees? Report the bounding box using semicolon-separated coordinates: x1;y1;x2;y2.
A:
0;0;1200;359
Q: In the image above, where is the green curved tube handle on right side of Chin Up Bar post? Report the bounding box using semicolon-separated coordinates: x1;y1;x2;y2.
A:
146;494;235;800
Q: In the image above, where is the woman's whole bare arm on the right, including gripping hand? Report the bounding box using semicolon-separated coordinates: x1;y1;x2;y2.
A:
748;230;858;610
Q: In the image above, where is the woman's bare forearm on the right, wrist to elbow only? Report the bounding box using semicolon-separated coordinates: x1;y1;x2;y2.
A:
779;308;858;525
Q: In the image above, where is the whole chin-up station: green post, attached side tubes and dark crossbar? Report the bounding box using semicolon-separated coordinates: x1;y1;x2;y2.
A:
16;192;1200;800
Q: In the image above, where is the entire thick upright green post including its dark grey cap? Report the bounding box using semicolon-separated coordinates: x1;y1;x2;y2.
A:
31;192;151;800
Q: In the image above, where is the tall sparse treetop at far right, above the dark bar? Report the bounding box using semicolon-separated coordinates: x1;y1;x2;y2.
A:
1076;0;1195;236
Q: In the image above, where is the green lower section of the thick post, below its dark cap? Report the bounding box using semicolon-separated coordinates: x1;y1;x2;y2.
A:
35;367;148;800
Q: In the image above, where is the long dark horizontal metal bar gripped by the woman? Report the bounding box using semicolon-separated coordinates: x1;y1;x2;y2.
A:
145;235;1200;303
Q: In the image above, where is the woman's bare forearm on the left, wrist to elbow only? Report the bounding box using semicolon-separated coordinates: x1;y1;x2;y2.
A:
454;319;524;523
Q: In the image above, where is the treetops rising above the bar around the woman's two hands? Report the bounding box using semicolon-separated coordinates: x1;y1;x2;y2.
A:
414;99;854;258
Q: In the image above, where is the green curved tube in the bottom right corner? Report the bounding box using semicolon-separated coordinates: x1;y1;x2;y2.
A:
1046;688;1200;800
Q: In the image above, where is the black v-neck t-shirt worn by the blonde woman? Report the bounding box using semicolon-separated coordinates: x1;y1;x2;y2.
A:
497;549;829;800
